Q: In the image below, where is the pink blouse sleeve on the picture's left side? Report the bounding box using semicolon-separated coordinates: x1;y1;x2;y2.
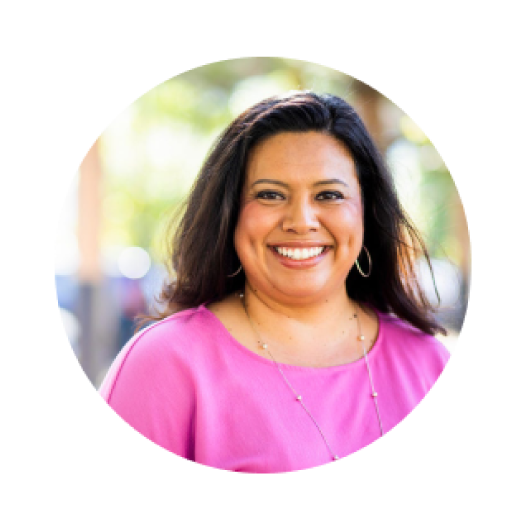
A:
98;325;195;462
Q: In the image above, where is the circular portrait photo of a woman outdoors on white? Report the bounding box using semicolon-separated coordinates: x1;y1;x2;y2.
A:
55;56;471;474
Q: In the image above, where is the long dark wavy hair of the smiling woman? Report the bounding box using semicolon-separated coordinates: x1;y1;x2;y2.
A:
135;91;447;335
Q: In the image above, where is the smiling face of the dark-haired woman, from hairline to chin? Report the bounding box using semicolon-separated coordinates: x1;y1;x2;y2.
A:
234;132;363;305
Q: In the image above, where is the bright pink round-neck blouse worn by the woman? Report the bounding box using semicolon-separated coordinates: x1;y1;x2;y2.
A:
98;305;451;474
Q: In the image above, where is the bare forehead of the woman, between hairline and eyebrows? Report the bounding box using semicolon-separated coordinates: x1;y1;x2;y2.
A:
246;131;357;183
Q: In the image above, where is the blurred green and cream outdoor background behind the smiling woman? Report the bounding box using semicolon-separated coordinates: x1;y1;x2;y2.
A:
54;56;472;396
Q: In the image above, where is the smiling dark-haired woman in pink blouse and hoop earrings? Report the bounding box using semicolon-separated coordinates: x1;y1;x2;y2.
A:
99;92;450;474
